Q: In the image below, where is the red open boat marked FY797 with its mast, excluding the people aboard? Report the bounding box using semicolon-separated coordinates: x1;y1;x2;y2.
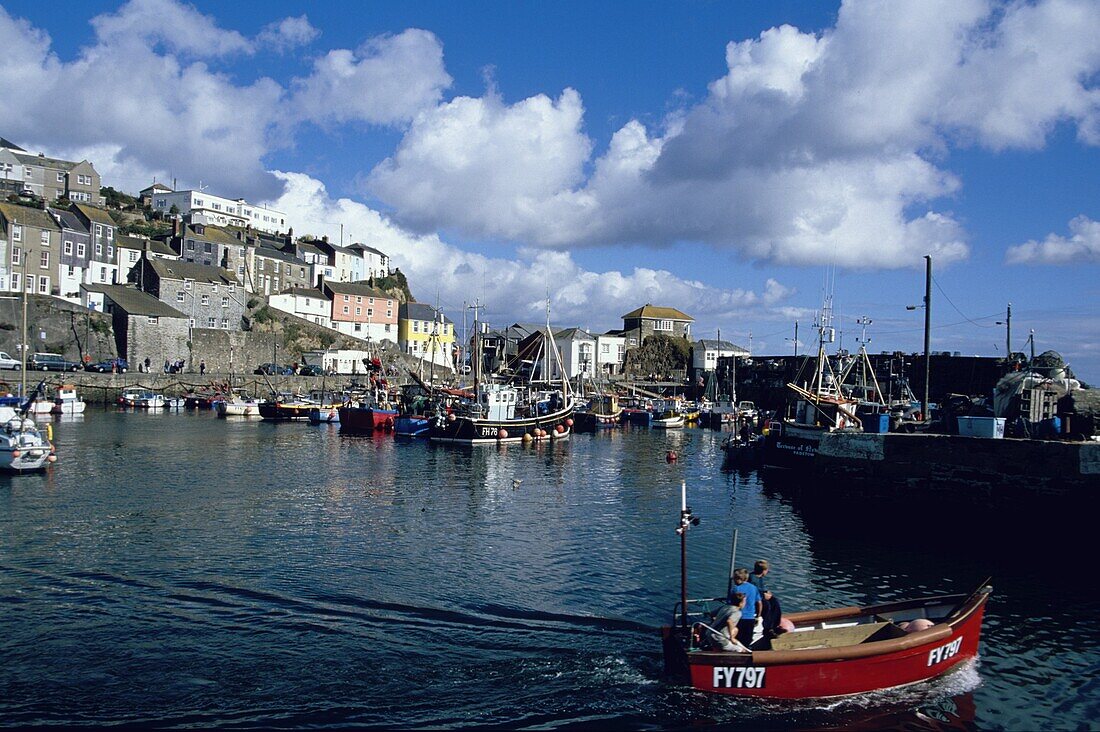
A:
661;482;992;699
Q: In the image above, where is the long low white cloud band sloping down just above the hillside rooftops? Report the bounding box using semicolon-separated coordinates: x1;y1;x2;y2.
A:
264;172;794;332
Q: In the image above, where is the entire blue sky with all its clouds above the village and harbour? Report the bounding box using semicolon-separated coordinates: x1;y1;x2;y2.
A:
0;0;1100;382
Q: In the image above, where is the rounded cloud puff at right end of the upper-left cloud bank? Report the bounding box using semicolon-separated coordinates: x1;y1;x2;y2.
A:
292;29;451;124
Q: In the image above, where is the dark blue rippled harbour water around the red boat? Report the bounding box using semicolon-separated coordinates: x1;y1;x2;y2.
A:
0;409;1100;730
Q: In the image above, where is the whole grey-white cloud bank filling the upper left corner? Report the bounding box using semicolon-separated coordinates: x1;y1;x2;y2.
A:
0;0;450;198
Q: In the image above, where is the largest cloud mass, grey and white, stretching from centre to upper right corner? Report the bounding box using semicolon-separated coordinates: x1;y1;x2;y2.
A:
370;0;1100;267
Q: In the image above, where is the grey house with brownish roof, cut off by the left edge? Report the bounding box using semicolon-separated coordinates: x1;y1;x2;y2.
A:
0;203;62;295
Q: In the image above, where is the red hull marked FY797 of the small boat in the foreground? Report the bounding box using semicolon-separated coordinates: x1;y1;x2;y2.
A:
662;593;988;699
